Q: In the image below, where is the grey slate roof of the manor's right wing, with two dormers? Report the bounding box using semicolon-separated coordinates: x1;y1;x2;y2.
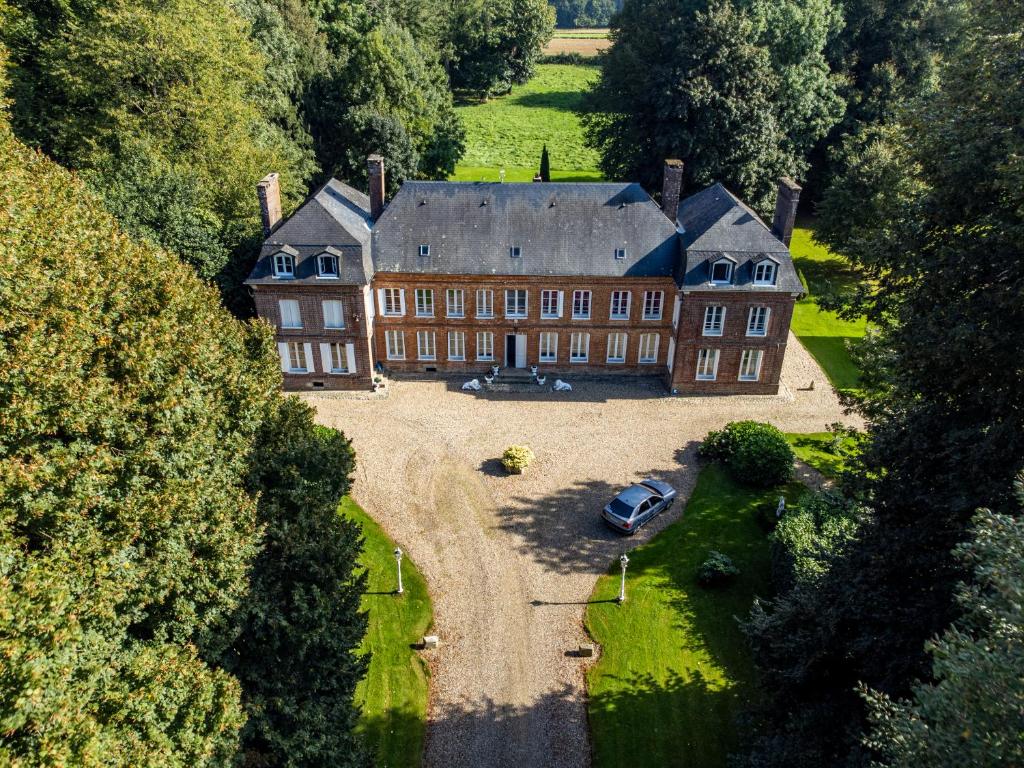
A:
676;184;804;293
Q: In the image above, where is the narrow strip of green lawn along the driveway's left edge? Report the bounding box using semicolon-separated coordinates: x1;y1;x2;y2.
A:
341;497;433;768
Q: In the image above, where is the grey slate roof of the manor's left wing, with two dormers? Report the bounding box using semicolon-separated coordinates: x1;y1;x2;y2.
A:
246;179;374;285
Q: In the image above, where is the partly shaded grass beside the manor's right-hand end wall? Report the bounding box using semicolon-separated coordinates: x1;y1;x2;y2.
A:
791;221;866;390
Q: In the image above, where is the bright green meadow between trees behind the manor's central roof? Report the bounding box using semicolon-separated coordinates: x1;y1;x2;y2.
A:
452;65;601;181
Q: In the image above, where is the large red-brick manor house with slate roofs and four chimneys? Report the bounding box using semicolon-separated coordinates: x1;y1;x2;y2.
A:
247;156;802;394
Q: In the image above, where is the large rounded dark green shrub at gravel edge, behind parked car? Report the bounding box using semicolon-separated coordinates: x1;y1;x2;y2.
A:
699;421;796;488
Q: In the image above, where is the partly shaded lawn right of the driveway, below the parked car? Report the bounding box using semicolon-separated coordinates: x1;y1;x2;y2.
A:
586;465;803;768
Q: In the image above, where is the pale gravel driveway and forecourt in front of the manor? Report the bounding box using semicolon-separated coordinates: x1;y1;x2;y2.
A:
304;336;857;768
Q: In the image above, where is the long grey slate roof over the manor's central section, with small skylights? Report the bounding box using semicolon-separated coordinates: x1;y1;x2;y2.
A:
373;181;679;276
